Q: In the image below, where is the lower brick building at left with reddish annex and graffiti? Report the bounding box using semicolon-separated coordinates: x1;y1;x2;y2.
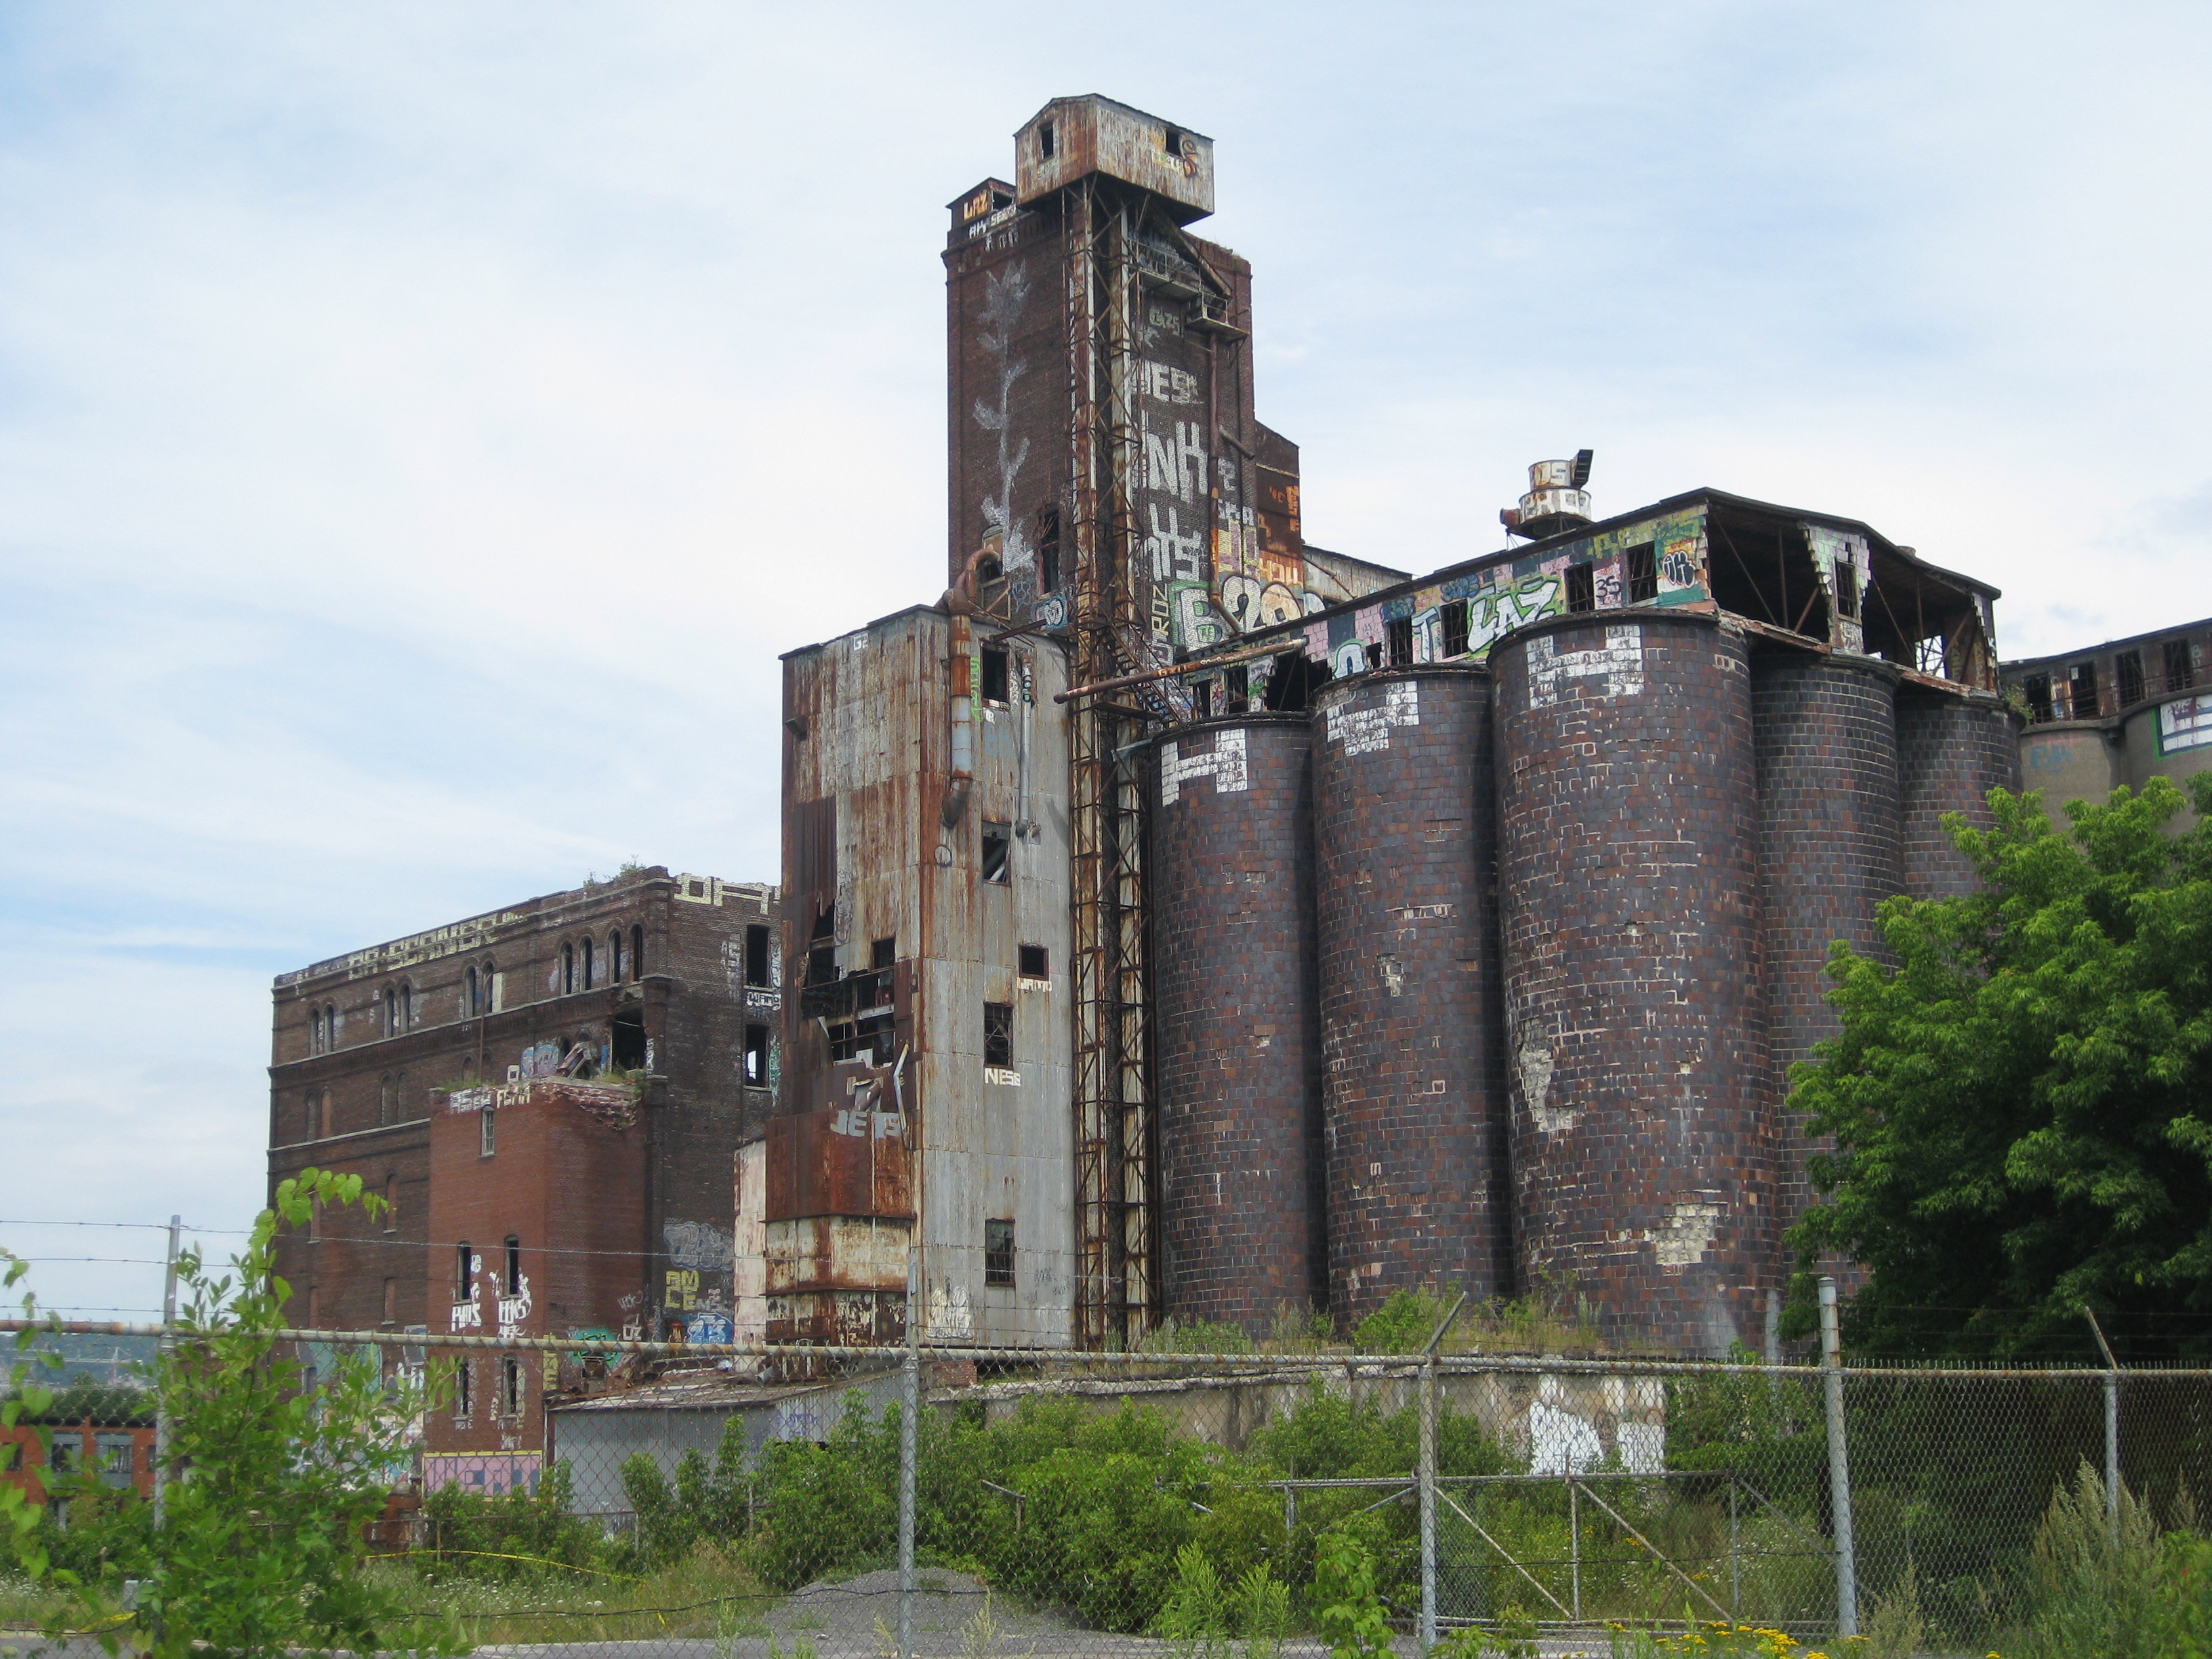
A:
268;867;783;1491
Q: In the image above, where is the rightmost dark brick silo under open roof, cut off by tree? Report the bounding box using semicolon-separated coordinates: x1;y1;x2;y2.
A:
1898;686;2020;898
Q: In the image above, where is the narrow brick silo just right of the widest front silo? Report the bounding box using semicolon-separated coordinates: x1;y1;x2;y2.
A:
1752;648;1904;1225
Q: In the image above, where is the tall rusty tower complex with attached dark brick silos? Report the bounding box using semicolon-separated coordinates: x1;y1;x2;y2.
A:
765;98;2052;1351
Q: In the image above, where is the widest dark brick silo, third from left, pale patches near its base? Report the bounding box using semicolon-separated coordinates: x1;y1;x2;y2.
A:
1491;611;1778;1354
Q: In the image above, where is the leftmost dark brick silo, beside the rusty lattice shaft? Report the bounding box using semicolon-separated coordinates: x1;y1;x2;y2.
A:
1146;714;1325;1336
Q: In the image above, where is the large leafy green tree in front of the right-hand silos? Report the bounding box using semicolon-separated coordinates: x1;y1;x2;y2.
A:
1790;774;2212;1358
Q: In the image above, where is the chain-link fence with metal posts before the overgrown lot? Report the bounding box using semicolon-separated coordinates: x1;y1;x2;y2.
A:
8;1332;2212;1659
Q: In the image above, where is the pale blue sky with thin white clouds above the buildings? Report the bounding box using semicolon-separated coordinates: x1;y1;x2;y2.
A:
0;0;2212;1318
